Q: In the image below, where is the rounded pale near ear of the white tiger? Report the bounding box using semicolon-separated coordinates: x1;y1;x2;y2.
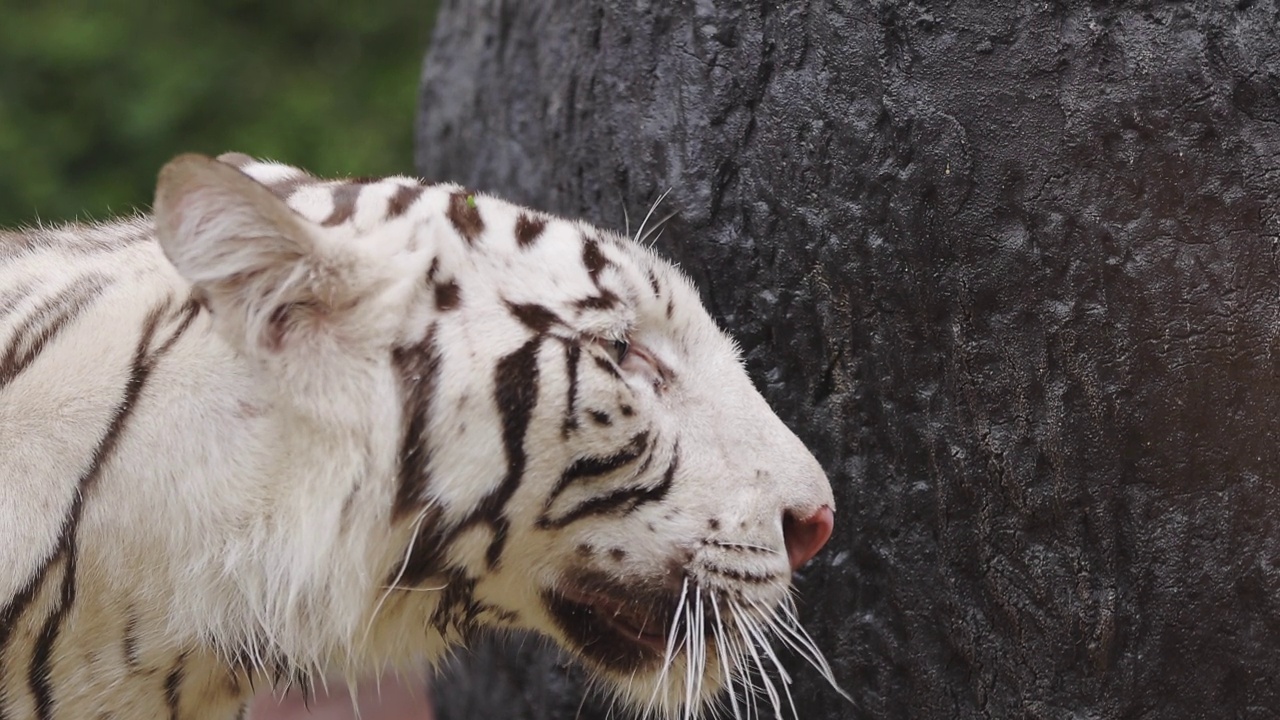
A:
155;155;358;351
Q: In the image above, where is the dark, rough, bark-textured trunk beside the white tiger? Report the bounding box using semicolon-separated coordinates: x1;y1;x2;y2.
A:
417;0;1280;720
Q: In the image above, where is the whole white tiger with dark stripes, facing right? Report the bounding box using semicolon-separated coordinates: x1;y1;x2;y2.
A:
0;154;835;719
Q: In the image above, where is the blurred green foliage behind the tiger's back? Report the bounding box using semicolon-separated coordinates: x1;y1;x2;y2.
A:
0;0;436;227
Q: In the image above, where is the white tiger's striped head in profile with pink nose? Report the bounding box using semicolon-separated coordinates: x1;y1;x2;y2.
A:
156;155;833;716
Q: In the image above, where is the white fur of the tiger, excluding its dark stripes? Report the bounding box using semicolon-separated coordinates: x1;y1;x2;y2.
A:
0;156;832;717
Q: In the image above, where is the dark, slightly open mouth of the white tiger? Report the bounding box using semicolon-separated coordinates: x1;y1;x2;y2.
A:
544;573;678;671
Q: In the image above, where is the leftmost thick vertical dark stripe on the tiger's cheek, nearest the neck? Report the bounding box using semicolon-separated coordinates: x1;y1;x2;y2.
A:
392;325;443;520
